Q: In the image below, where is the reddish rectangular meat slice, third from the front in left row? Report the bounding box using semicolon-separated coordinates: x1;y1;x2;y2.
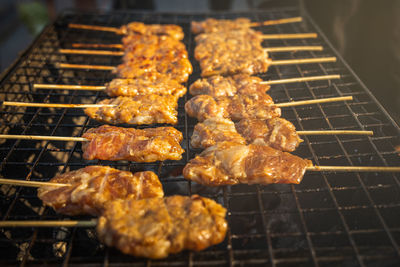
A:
82;125;185;162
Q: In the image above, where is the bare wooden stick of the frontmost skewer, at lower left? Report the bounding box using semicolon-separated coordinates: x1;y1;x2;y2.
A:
0;220;97;227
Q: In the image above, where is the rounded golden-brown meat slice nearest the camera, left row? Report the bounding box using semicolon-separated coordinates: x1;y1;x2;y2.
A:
97;195;227;259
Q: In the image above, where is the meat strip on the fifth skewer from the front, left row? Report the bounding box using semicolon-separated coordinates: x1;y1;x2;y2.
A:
106;74;186;98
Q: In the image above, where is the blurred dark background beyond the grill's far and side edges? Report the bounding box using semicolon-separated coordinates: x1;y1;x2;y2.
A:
0;0;400;123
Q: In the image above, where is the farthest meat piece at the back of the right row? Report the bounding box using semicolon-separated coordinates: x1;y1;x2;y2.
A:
192;18;251;34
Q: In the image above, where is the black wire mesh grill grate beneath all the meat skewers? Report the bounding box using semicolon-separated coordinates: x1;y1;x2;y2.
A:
0;8;400;266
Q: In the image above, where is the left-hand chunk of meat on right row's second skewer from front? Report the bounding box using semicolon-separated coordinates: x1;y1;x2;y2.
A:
190;117;246;148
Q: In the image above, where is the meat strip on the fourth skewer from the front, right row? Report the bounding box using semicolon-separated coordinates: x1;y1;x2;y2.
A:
189;74;270;96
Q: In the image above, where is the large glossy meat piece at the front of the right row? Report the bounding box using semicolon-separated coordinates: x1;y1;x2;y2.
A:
183;142;312;186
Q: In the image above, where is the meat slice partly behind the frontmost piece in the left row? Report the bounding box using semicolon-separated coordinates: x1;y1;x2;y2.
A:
38;166;164;216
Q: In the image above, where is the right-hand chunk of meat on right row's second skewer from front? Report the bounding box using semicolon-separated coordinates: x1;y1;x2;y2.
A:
236;118;303;152
